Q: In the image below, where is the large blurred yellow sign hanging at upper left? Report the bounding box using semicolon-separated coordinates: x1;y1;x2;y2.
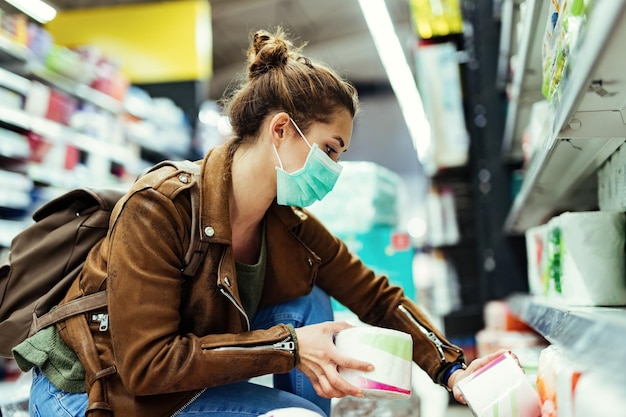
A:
45;0;212;83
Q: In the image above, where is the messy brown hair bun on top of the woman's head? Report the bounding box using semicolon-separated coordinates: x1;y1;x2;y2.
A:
248;28;294;79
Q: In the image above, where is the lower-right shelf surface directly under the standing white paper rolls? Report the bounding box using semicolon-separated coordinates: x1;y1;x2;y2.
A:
508;295;626;378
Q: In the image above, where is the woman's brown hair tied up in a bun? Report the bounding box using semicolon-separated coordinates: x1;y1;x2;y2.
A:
223;28;358;142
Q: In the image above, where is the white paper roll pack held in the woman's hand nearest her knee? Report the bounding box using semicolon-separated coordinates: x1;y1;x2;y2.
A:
335;327;413;399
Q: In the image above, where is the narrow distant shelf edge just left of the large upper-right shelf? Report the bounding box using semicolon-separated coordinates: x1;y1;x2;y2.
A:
502;0;550;161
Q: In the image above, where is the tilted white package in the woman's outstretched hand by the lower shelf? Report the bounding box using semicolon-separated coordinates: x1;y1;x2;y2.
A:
457;353;541;417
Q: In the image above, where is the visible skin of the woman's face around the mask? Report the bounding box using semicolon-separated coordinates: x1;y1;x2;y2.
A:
281;110;353;172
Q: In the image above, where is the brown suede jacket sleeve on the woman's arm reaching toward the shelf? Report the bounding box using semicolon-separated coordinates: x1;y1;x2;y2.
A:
299;213;465;384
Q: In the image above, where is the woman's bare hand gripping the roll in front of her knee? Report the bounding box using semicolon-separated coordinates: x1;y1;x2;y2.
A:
296;321;374;398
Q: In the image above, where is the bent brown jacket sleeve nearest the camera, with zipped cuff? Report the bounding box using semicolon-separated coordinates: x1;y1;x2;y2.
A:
105;189;295;395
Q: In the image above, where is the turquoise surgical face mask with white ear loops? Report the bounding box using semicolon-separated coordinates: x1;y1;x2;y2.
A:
272;119;343;207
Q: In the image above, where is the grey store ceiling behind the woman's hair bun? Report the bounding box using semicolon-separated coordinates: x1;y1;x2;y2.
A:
47;0;414;99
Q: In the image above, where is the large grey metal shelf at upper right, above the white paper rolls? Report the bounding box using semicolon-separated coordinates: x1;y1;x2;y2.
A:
505;1;626;234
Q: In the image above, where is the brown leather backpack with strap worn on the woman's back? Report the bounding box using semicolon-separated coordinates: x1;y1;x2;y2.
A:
0;161;206;358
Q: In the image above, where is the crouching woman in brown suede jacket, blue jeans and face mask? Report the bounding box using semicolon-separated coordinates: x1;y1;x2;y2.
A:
18;30;498;417
